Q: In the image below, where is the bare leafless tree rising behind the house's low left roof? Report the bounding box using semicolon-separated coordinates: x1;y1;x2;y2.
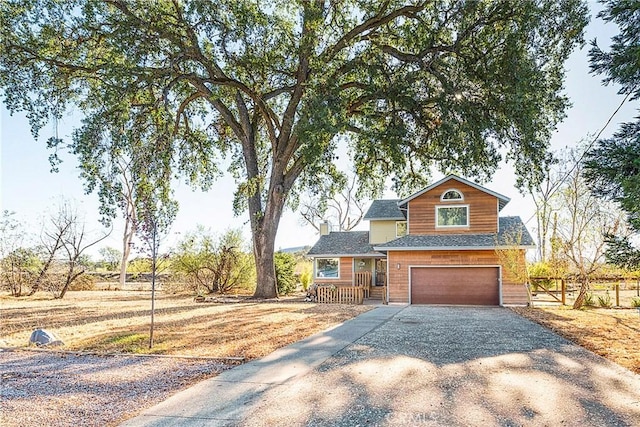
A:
300;176;365;231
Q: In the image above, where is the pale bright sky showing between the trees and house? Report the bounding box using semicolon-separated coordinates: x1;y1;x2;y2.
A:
0;2;638;258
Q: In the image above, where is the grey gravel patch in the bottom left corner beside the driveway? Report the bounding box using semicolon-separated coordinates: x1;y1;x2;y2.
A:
0;350;227;427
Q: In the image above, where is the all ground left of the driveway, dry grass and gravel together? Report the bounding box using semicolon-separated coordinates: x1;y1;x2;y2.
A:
0;291;372;427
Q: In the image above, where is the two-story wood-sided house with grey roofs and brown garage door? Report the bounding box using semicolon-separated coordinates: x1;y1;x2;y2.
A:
309;175;534;305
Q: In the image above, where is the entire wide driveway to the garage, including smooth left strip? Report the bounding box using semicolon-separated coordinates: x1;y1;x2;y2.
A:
123;306;640;426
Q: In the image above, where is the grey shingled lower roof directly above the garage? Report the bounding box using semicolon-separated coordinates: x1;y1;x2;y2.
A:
374;216;535;251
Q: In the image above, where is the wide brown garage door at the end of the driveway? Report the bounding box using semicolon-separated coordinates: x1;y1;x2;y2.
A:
411;267;500;305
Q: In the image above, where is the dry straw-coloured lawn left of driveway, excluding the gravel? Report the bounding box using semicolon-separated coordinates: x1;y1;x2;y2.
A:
0;291;371;360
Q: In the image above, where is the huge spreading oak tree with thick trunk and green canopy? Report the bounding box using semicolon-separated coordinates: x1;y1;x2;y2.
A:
0;0;587;297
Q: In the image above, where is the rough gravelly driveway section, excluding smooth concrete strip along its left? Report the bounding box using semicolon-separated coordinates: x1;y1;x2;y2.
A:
242;306;640;426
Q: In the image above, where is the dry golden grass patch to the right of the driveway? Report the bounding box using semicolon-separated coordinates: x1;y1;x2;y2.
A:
513;307;640;374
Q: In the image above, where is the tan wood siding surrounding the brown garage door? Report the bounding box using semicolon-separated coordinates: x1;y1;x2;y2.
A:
388;249;528;305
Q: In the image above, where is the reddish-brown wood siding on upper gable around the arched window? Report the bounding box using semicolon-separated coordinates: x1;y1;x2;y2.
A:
408;180;498;234
